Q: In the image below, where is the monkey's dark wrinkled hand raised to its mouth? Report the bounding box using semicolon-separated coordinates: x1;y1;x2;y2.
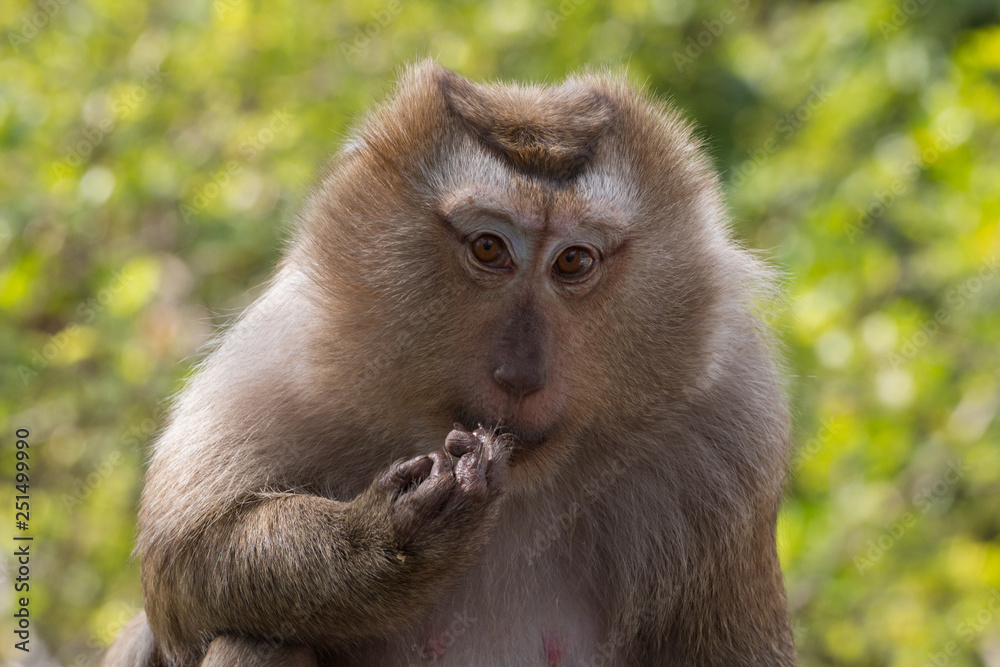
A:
359;424;509;566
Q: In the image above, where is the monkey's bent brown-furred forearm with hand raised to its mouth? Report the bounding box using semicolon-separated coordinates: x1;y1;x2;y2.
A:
143;432;503;664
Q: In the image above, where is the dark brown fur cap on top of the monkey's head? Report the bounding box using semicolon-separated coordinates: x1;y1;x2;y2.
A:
433;65;616;181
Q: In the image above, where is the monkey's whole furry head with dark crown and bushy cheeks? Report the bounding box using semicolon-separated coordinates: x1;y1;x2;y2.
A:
289;62;753;478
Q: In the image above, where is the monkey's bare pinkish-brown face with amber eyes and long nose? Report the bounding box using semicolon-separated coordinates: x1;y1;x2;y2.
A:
437;185;625;448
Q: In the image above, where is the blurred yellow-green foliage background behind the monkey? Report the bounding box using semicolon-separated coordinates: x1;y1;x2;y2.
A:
0;0;1000;666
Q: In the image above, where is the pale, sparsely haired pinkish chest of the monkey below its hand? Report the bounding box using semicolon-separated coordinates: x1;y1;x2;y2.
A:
342;582;616;667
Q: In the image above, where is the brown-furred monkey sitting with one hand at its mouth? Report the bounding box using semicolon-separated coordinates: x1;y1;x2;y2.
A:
104;60;796;667
